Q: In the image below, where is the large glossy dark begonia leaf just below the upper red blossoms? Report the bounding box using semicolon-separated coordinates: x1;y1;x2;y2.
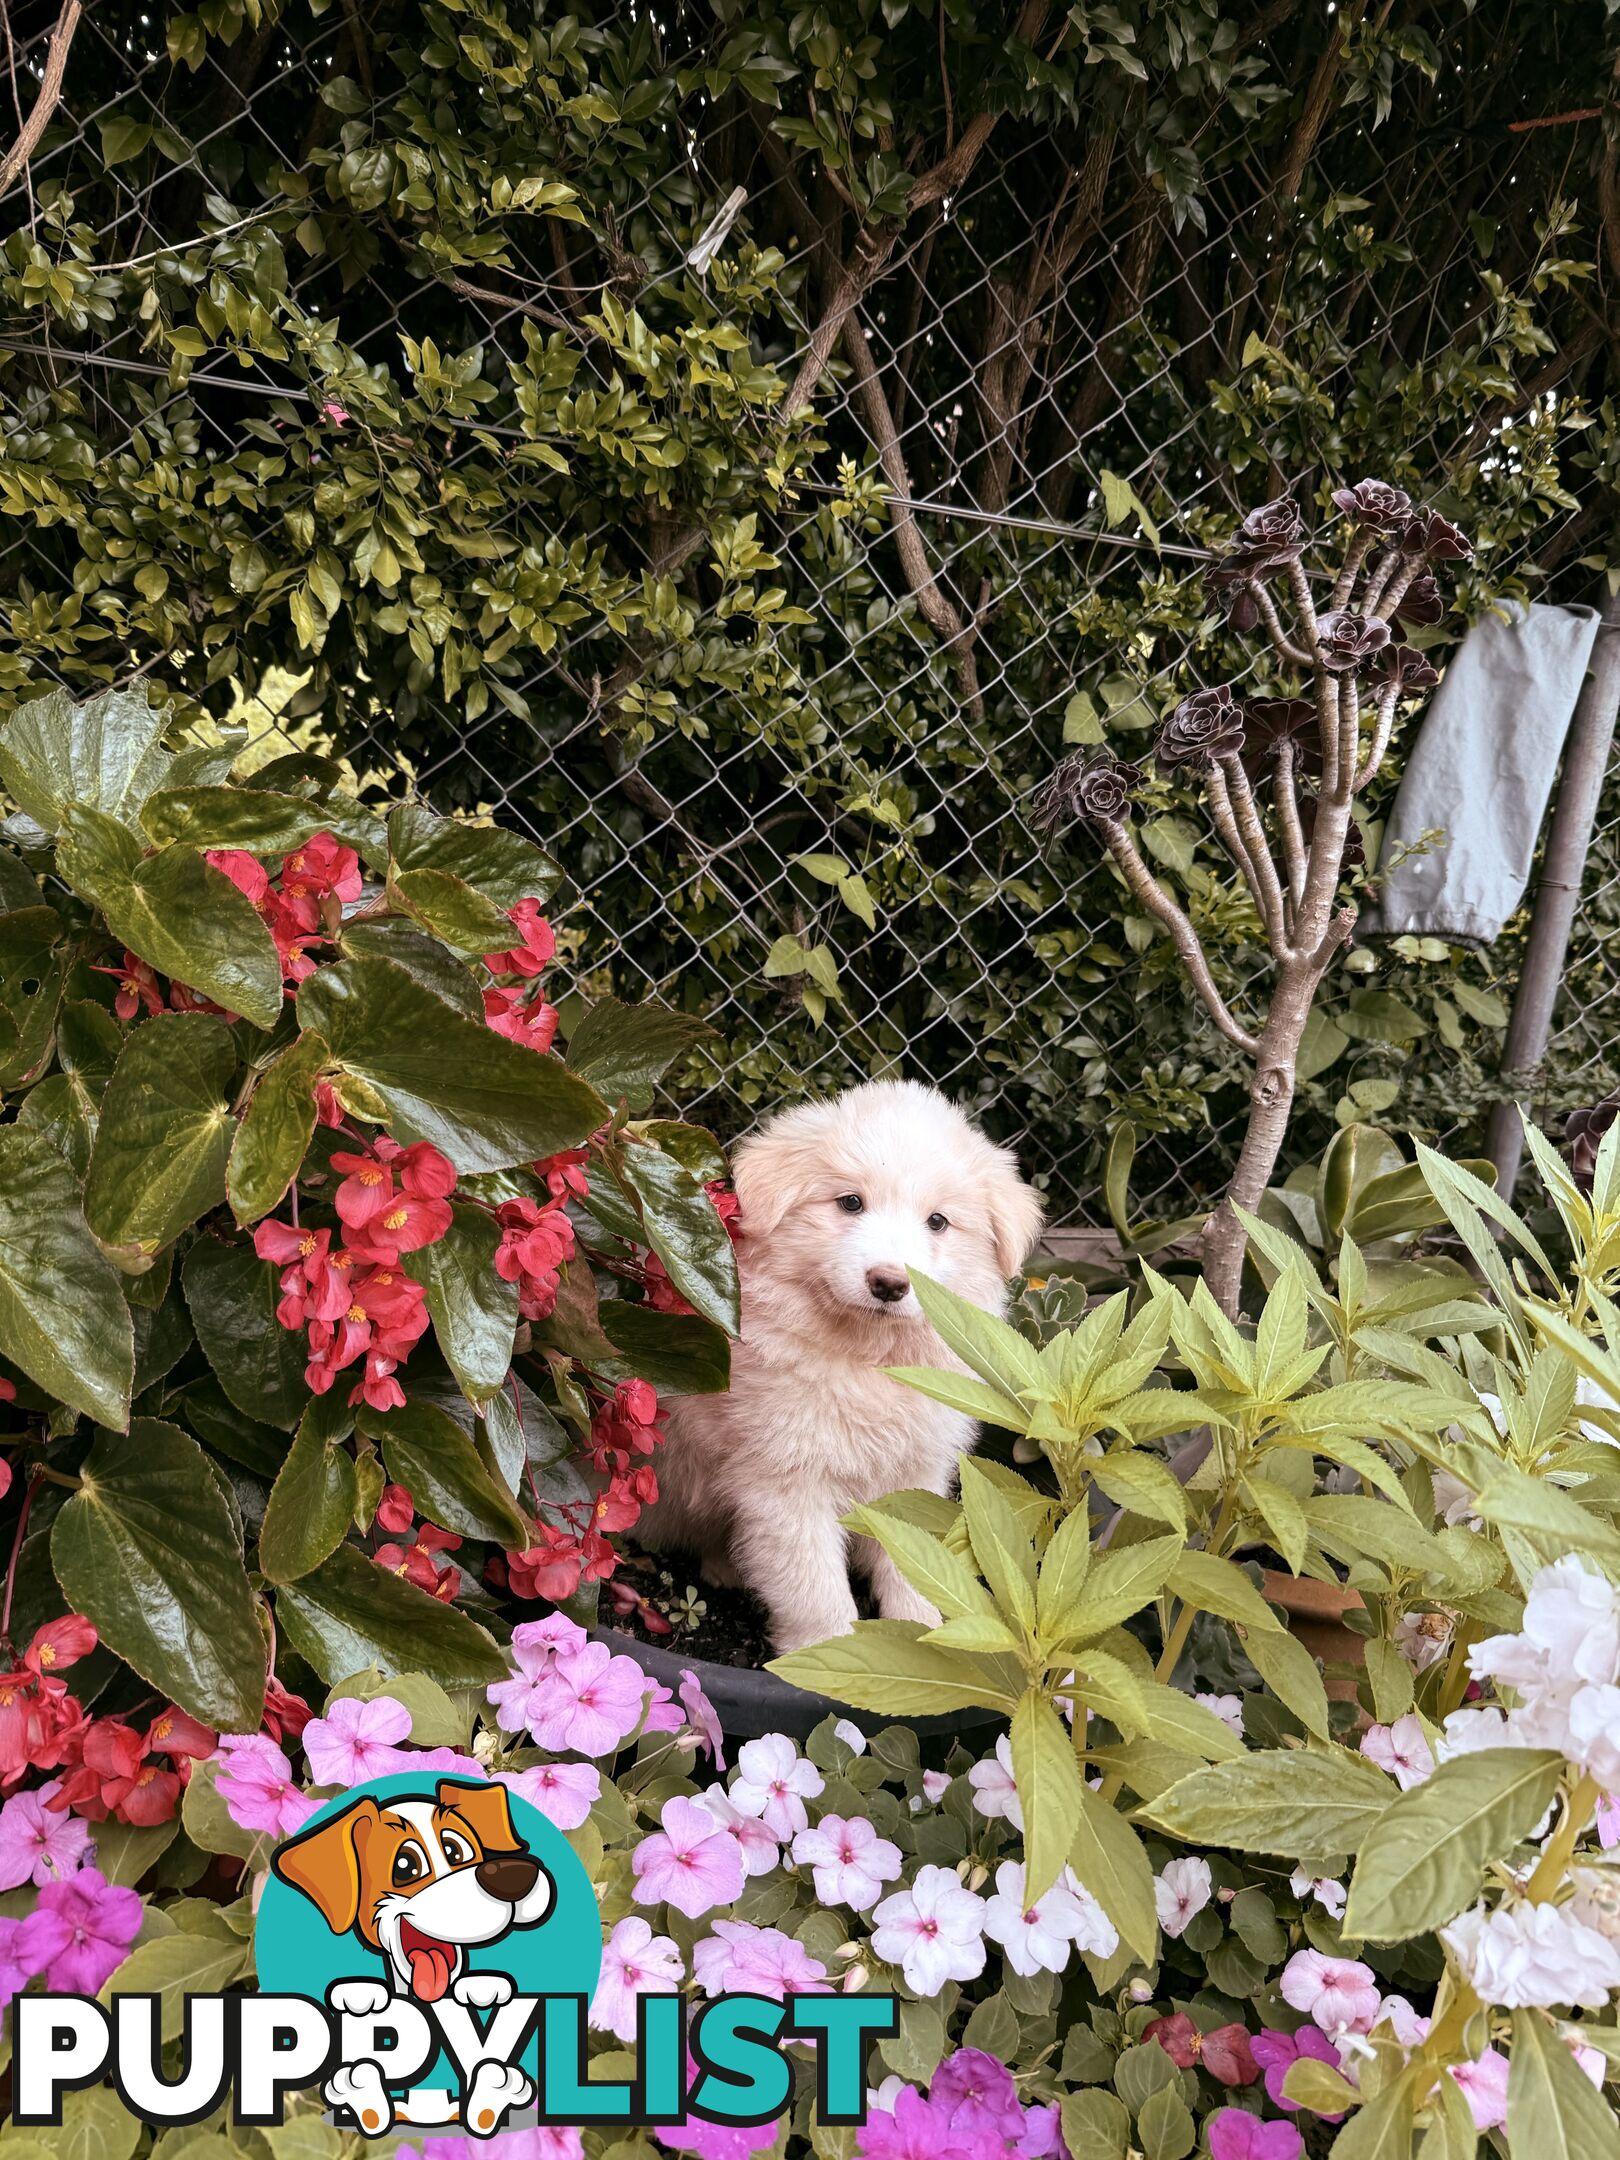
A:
298;957;609;1175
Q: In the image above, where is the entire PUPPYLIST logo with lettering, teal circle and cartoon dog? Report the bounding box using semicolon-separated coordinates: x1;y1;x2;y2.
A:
13;1773;899;2138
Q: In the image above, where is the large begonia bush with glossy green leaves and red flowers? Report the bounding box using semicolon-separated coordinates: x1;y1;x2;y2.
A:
0;689;737;1745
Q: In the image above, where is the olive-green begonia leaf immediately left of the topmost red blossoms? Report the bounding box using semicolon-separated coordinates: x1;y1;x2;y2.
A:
56;804;283;1028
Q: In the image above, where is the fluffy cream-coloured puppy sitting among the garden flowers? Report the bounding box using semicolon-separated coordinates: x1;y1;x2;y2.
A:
646;1082;1041;1650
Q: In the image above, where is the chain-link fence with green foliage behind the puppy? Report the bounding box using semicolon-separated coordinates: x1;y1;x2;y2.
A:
0;0;1620;1223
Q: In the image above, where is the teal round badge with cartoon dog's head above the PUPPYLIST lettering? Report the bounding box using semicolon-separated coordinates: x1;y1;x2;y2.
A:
253;1771;603;2125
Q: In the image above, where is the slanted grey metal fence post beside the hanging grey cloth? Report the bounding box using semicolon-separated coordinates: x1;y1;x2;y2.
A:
1486;592;1620;1199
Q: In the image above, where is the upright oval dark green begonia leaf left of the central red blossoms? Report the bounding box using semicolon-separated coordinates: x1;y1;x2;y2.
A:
84;1013;235;1253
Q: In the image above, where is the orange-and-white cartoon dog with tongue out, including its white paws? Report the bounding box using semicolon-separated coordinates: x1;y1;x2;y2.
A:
270;1778;557;2136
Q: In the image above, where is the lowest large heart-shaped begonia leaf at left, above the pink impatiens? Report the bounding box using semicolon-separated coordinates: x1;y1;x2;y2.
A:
50;1417;264;1732
